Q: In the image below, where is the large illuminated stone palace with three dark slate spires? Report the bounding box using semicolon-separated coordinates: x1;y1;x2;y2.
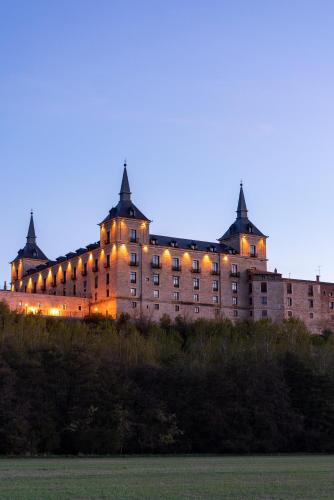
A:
0;165;334;333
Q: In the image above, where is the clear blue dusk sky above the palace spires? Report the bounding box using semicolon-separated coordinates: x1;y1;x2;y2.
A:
0;0;334;283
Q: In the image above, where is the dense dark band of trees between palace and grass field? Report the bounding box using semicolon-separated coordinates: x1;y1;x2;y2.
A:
0;304;334;455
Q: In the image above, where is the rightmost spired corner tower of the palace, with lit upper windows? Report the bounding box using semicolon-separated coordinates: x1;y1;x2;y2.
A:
218;182;267;262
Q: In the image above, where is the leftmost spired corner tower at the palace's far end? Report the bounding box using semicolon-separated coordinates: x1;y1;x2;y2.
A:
11;212;49;283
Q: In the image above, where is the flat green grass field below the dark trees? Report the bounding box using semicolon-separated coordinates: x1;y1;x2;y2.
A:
0;455;334;500
